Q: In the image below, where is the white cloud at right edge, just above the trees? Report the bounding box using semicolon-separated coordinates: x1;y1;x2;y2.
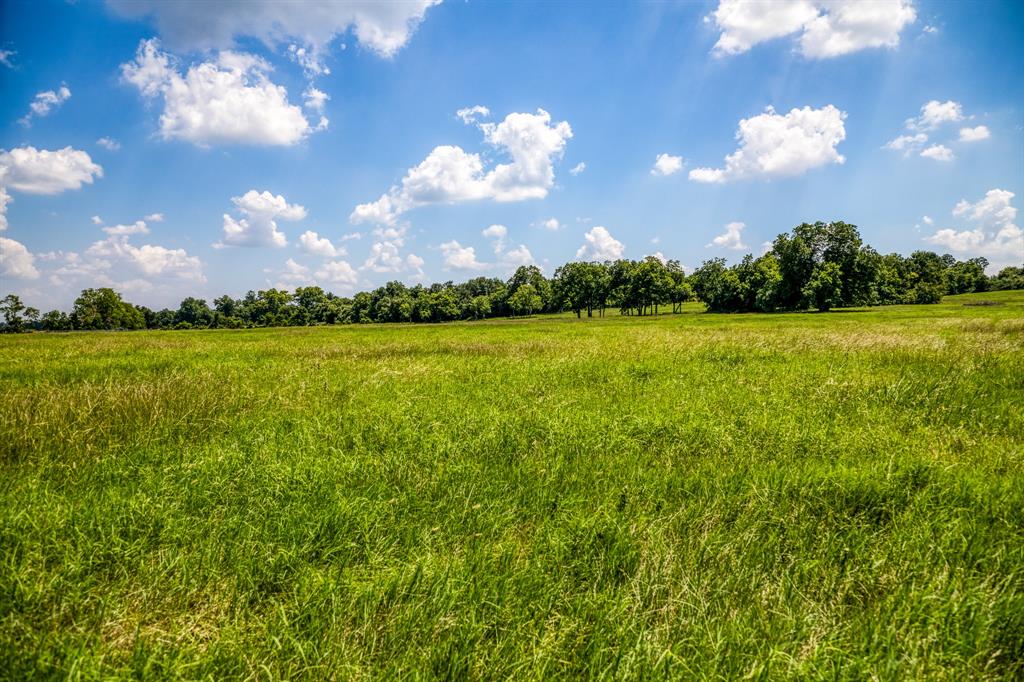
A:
926;189;1024;270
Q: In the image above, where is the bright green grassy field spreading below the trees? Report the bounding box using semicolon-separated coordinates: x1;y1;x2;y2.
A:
6;292;1024;680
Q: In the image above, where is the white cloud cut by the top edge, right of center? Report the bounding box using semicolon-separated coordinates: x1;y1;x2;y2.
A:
706;0;916;59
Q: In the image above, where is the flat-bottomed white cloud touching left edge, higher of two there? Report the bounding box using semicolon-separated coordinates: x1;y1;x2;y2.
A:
0;146;103;195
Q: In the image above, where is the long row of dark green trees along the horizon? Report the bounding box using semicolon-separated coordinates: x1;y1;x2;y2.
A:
0;221;1024;332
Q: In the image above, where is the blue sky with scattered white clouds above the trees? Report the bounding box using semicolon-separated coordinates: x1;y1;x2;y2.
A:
0;0;1024;308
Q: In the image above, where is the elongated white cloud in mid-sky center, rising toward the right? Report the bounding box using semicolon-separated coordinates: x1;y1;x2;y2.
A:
349;109;572;224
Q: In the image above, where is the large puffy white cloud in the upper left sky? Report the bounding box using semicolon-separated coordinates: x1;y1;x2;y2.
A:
121;39;317;146
